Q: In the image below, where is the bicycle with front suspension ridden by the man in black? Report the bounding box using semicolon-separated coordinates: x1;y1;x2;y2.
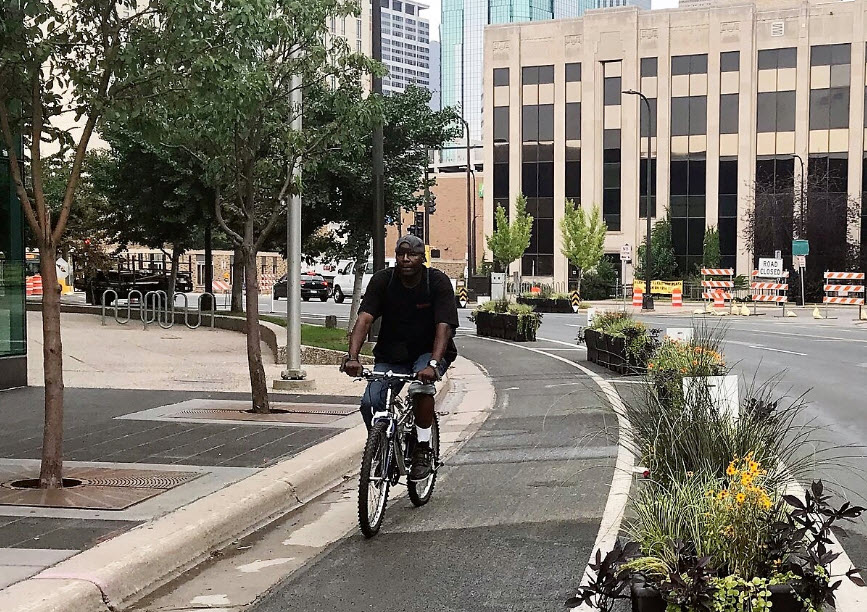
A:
358;370;440;538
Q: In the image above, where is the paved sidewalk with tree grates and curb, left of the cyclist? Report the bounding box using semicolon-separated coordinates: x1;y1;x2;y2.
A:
0;312;468;612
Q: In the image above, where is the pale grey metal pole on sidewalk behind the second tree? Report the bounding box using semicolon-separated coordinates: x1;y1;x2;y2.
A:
281;58;307;380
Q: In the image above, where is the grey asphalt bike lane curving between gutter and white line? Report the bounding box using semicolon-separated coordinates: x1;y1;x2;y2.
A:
249;338;617;612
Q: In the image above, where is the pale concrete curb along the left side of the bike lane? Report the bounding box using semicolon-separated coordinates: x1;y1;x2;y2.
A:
0;366;451;612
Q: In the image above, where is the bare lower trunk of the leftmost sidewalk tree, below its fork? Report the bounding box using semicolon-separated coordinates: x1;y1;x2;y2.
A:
39;245;63;489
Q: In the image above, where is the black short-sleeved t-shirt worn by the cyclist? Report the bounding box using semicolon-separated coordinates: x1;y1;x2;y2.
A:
359;268;458;363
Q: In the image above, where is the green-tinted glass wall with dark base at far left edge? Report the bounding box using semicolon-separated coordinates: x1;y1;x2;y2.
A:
0;150;27;378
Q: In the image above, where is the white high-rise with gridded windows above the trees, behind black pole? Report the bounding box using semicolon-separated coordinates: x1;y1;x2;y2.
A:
379;0;431;93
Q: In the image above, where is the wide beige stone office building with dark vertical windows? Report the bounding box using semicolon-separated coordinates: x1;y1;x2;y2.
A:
484;0;867;282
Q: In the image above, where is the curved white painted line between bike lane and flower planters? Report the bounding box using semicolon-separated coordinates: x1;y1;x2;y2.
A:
468;338;635;610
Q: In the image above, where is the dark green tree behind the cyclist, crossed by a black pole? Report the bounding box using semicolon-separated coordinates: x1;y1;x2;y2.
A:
302;85;459;330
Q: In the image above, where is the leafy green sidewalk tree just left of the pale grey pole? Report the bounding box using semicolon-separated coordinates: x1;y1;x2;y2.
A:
137;0;381;413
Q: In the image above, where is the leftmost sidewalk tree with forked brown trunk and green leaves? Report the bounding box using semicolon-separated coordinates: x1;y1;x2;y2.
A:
0;0;172;488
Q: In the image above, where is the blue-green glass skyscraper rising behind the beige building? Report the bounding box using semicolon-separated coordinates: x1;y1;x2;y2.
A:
440;0;597;161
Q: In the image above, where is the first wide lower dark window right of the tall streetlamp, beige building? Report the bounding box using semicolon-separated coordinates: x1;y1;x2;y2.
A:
671;156;707;274
